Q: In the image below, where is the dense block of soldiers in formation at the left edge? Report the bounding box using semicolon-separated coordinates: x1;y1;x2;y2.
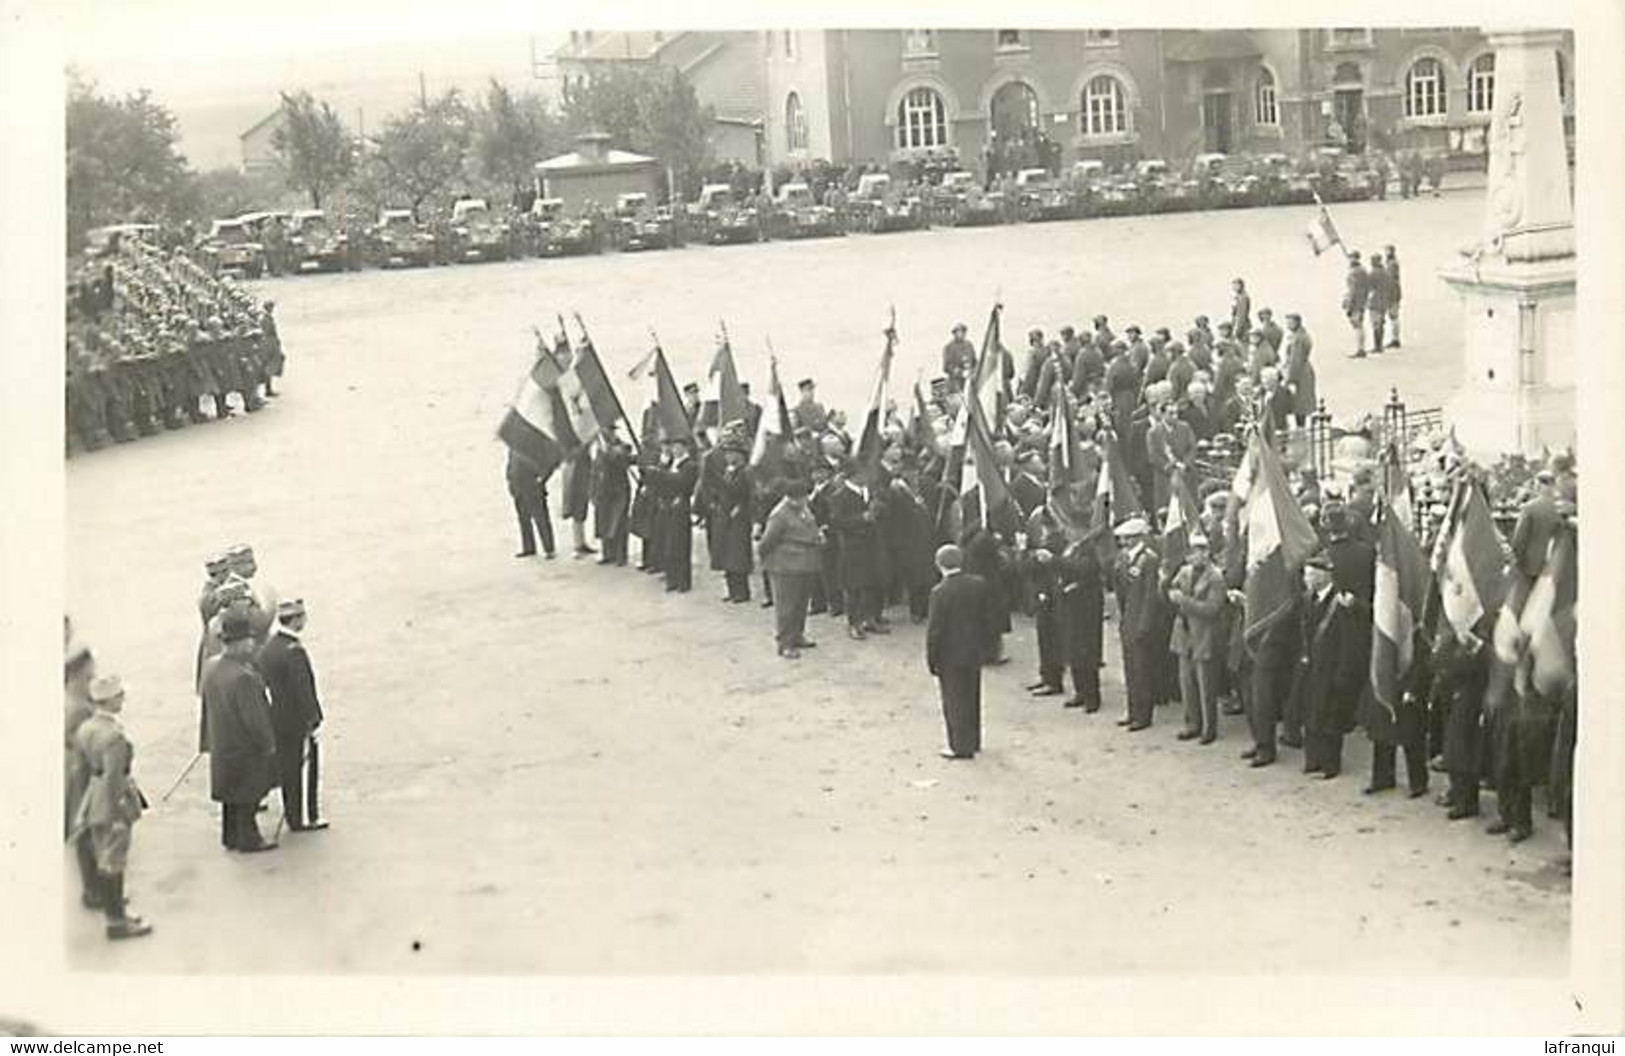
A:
65;239;284;452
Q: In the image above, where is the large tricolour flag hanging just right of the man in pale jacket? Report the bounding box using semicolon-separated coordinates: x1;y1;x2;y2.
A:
1243;432;1320;640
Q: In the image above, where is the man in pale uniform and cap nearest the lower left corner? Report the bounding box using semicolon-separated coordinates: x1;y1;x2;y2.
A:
76;676;153;939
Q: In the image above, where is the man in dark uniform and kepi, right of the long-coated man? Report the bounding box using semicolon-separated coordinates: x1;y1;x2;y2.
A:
258;598;327;832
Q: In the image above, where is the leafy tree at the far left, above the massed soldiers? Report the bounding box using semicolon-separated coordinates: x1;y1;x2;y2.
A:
65;75;197;247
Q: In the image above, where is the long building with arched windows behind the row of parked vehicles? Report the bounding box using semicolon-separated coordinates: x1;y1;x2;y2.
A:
756;28;1575;169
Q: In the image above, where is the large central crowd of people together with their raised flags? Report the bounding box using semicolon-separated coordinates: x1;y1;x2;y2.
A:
499;292;1576;840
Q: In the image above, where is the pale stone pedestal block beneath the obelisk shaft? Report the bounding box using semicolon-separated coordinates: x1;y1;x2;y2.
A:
1440;257;1575;461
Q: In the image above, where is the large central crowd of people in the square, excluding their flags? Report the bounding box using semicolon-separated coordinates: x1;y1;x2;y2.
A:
510;308;1575;840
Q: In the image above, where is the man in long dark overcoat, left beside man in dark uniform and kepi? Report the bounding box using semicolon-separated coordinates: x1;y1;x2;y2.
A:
203;611;278;853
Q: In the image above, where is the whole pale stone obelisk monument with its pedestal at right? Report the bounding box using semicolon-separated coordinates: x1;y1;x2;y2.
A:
1441;29;1576;460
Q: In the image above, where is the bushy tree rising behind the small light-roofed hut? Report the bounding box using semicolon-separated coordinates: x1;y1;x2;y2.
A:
564;67;713;201
